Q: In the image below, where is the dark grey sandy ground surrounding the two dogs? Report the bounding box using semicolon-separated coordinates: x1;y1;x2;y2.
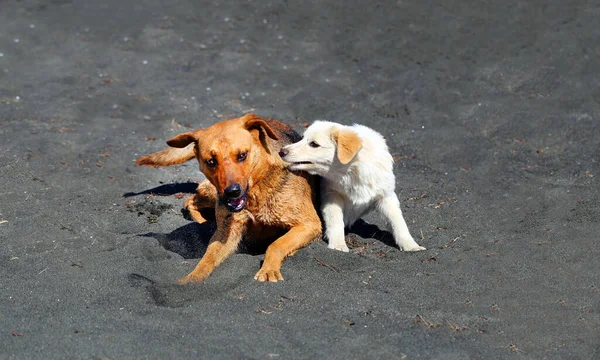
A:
0;0;600;359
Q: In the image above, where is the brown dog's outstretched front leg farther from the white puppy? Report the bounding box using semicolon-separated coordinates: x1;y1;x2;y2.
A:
177;207;252;284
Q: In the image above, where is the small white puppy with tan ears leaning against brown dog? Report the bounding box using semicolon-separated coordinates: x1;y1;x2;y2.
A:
280;121;425;252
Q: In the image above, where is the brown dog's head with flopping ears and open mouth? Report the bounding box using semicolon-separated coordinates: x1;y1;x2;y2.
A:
167;114;279;212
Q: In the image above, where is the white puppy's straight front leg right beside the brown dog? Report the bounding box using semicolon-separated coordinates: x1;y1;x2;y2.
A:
321;193;350;252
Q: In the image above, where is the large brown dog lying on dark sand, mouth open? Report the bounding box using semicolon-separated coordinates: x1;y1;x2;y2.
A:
137;114;321;283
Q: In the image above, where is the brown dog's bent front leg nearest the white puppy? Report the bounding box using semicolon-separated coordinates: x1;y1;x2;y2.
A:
254;223;321;282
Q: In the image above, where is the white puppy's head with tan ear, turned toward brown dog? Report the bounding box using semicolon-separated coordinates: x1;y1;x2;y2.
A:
279;120;362;177
